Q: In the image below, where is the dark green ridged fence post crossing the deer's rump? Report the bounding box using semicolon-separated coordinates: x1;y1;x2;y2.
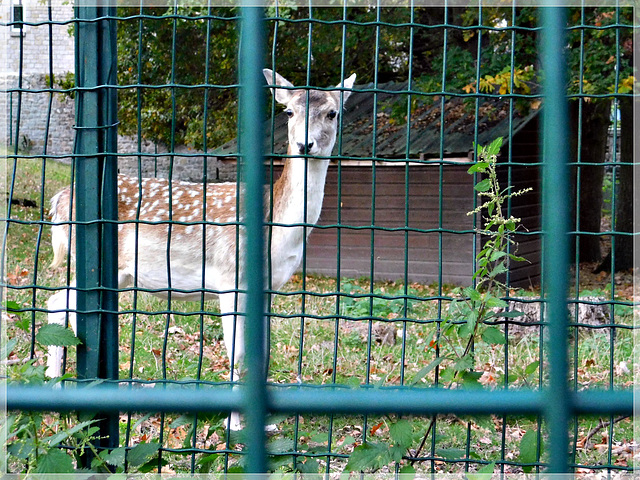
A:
74;0;119;454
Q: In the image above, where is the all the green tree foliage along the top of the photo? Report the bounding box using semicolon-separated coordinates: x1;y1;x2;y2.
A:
111;5;634;149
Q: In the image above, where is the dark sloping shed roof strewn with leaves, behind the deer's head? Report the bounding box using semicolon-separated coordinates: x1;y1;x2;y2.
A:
214;82;540;159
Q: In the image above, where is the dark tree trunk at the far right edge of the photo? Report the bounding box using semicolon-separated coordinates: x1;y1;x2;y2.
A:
596;97;634;272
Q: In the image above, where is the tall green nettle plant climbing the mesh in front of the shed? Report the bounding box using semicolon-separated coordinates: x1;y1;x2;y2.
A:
346;138;538;474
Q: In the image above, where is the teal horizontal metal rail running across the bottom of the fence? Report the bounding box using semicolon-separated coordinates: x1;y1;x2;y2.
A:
6;385;640;415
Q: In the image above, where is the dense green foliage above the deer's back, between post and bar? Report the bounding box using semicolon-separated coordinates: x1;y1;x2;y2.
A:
118;6;238;148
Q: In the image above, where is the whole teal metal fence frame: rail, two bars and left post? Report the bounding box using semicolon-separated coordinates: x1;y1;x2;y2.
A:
6;2;634;473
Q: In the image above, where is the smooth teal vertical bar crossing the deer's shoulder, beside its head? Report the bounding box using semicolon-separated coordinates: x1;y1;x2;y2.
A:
239;1;267;473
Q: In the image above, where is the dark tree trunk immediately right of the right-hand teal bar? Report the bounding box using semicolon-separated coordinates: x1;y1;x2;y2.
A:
574;100;611;262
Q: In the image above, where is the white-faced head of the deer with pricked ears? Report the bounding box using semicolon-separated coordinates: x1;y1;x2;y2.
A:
262;68;356;157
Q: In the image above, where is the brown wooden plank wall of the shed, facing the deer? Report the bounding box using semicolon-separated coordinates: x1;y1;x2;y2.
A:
296;165;477;284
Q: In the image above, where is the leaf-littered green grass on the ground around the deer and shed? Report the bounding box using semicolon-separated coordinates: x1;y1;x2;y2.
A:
4;159;639;472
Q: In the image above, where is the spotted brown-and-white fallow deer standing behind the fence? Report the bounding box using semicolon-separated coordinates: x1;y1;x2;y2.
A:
47;69;356;429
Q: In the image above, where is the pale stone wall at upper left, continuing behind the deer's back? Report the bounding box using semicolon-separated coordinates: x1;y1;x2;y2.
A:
0;0;236;182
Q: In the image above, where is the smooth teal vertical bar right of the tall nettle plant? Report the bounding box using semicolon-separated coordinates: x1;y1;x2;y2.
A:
541;7;571;473
